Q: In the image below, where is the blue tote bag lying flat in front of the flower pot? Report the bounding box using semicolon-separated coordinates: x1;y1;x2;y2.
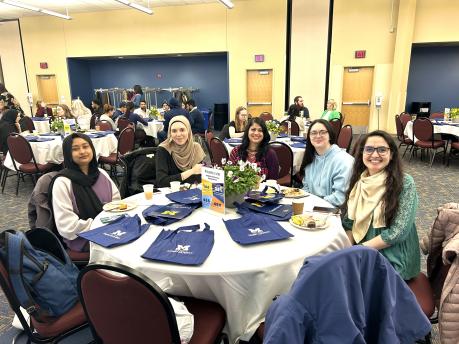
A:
223;214;293;245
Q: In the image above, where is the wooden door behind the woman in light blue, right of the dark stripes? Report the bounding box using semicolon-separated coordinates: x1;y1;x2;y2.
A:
341;67;373;133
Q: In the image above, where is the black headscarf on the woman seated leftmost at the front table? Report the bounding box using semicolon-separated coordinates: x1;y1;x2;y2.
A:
59;133;102;220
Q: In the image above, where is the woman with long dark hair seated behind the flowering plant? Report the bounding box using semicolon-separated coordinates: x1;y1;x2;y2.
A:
230;117;279;179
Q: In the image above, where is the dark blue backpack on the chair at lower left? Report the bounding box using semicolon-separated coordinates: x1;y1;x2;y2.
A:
0;228;78;321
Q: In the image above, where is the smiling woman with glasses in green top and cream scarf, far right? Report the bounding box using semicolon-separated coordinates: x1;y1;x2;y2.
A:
343;130;421;280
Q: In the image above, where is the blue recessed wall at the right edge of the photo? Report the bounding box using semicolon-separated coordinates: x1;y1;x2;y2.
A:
405;46;459;113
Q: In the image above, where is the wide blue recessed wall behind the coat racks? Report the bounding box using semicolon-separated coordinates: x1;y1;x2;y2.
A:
68;53;229;109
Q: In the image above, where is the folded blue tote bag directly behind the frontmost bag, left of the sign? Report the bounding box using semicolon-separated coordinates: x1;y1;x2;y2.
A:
142;203;200;226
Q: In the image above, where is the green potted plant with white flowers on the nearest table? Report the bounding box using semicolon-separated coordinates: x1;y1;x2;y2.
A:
222;160;265;208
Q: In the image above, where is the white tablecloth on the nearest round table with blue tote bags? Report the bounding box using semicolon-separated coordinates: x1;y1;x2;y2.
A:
91;190;350;343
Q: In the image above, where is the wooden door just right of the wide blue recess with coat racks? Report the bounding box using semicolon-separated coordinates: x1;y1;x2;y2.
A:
247;69;273;116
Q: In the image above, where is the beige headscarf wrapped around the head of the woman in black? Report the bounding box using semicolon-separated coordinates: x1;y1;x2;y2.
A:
159;116;206;171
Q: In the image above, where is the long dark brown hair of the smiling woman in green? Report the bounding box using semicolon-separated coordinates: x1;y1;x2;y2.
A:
344;130;403;227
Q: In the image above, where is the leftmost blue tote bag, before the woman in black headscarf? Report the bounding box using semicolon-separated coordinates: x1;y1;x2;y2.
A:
78;215;150;247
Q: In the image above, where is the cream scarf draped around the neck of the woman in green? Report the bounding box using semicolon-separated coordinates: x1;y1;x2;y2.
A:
347;170;387;243
